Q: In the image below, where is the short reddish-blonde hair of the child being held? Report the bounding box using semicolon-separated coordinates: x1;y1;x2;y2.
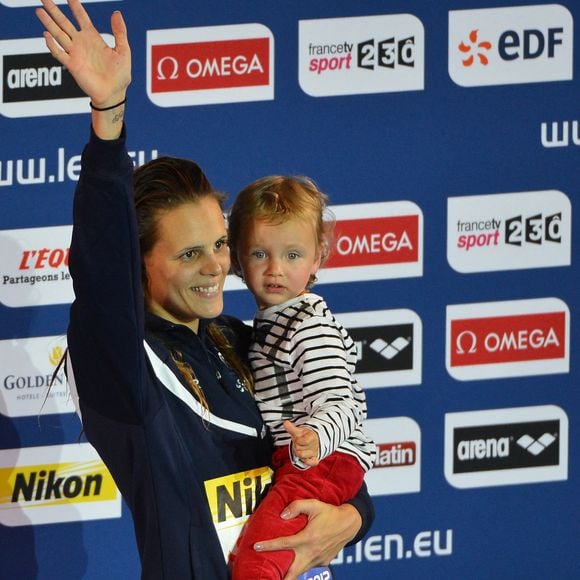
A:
228;175;335;288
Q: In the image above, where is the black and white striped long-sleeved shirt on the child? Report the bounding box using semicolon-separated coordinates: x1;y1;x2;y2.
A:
249;293;376;471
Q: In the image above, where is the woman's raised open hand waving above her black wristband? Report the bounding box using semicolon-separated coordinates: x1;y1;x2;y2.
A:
36;0;131;108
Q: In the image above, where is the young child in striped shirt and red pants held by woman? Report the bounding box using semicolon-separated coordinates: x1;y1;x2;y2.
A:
229;176;375;580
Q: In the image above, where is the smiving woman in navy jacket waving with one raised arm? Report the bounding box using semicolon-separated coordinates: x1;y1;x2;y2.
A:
37;0;372;580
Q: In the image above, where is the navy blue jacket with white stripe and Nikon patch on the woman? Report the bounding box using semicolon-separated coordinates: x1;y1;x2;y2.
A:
67;132;373;580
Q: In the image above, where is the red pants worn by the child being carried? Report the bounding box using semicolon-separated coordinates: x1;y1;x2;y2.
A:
230;447;364;580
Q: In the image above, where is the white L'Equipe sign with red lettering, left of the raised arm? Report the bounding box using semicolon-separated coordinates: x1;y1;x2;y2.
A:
0;226;74;307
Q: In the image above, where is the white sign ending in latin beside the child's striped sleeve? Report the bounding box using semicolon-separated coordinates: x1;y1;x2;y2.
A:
364;417;421;496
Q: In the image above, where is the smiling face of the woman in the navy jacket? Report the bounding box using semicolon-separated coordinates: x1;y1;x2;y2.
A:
144;196;230;332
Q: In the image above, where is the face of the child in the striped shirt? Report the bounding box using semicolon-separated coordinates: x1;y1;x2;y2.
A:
239;219;320;309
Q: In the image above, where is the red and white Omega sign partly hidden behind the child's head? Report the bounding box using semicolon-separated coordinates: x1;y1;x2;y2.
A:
226;201;423;290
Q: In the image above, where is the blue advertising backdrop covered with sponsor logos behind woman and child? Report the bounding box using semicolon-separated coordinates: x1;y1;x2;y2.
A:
0;0;580;580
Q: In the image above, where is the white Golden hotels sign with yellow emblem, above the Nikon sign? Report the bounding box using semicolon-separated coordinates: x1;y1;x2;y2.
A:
0;336;74;417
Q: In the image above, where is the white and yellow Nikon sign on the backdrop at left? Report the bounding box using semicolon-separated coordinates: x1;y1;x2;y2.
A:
0;443;121;526
